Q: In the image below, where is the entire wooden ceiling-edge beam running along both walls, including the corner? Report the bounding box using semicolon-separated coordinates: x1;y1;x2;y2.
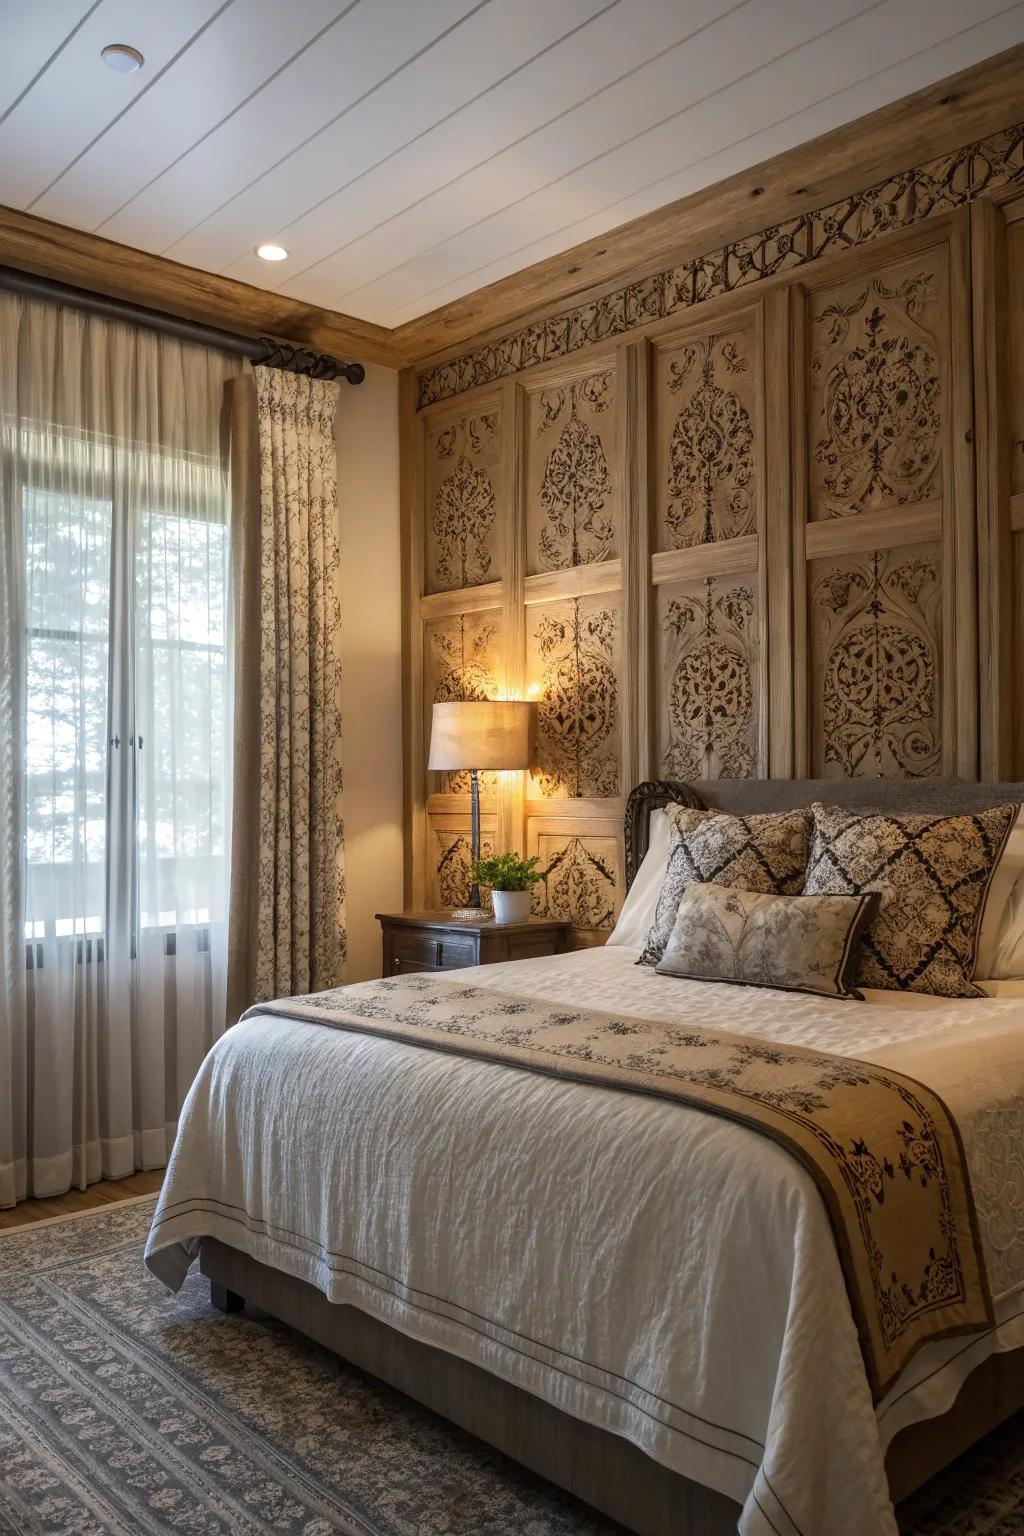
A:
0;45;1024;377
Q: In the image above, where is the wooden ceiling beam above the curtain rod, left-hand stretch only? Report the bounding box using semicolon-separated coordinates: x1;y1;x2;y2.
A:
0;207;401;367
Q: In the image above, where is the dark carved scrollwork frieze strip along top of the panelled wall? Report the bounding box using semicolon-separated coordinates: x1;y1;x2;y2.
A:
419;124;1024;409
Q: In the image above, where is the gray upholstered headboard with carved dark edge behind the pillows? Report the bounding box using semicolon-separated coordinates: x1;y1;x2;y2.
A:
625;779;1024;888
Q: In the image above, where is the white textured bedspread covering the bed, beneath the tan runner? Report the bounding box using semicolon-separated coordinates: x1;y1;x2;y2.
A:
146;948;1024;1536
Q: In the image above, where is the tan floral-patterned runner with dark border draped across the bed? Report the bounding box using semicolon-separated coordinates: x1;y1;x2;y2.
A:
244;975;993;1401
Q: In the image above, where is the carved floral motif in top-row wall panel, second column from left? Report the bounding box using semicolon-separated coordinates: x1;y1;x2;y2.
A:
537;373;614;570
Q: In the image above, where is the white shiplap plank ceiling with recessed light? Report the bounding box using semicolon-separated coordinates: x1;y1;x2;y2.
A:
0;0;1024;326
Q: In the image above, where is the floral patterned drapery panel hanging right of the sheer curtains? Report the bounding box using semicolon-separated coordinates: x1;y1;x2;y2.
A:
230;367;345;1009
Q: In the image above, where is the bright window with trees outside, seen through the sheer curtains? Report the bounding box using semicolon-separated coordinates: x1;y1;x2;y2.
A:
20;436;230;965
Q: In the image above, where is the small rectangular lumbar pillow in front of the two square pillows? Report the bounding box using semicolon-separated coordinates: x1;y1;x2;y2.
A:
657;885;881;998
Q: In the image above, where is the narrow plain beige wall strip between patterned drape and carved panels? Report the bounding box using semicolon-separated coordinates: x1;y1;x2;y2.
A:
338;367;402;982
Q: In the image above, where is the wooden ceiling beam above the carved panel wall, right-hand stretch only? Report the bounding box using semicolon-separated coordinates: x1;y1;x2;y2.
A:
391;45;1024;364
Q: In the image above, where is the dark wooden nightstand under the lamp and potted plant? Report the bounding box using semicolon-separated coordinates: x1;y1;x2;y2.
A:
376;912;570;975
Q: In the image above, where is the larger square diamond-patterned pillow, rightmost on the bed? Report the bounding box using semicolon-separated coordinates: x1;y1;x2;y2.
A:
804;805;1016;997
